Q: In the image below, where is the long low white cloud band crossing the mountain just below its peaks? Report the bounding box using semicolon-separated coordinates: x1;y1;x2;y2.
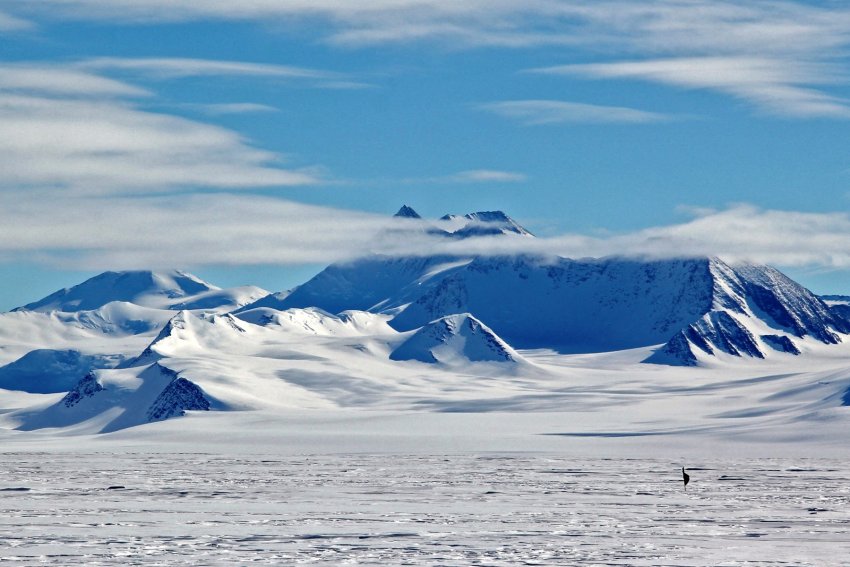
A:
0;193;850;276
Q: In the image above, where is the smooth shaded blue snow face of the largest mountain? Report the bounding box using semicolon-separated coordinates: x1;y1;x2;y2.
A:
392;256;711;352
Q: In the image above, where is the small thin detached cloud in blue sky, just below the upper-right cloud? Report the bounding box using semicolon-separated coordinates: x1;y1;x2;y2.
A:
479;100;671;125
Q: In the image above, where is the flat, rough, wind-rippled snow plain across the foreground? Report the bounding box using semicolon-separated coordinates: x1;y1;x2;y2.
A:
0;446;850;565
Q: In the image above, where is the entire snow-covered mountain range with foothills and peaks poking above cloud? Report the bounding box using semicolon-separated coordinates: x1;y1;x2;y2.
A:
0;206;850;432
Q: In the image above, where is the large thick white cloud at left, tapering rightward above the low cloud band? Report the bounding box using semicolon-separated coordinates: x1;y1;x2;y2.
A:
0;65;317;193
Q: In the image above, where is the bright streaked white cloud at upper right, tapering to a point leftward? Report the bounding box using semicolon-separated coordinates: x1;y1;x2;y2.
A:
534;56;850;118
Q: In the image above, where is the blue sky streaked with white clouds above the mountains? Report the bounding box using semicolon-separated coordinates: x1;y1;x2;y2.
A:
0;0;850;309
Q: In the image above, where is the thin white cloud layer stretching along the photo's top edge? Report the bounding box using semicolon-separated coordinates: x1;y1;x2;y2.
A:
15;0;850;54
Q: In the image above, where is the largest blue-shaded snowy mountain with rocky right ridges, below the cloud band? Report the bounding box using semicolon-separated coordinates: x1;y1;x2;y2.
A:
270;247;850;365
